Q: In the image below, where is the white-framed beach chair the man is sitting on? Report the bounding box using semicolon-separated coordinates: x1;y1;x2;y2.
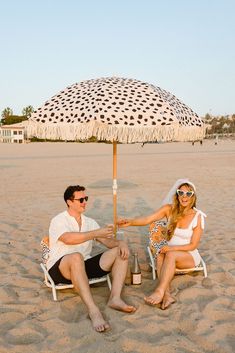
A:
40;236;111;301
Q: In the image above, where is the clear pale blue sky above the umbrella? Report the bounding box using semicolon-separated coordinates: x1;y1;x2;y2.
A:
0;0;235;116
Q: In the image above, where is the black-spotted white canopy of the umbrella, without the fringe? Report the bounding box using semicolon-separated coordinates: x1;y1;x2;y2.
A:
31;77;203;127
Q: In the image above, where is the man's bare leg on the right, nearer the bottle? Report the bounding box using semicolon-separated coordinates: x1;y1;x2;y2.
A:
100;248;136;313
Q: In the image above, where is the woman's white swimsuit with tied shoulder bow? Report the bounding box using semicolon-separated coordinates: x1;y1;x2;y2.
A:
168;207;206;266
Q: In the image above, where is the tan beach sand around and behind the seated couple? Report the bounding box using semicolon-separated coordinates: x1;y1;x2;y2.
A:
0;140;235;353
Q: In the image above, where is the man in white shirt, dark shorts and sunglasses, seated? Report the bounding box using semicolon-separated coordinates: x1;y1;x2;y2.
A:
47;185;136;332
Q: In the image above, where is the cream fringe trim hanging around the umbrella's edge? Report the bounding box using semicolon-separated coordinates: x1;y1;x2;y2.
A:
26;120;205;143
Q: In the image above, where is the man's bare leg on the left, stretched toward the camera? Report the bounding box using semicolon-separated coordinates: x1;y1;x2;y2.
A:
59;253;110;332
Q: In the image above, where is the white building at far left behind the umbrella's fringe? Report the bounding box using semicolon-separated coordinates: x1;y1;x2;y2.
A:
0;123;26;143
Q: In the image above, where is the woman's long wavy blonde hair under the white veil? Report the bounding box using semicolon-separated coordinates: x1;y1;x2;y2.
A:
167;183;197;240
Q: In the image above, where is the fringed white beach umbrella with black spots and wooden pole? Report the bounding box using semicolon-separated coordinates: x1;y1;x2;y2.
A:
27;77;205;231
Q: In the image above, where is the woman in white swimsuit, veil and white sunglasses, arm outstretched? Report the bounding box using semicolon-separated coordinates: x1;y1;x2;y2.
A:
118;179;206;309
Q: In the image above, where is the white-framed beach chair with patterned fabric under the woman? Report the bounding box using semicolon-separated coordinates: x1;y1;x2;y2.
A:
147;221;207;280
